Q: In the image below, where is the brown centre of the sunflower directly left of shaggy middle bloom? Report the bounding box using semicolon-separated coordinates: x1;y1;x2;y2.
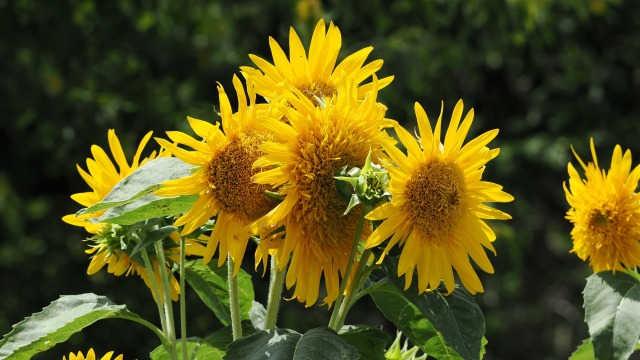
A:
209;130;274;220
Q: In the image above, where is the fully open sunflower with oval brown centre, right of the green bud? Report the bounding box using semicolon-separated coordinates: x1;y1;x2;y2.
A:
366;100;513;294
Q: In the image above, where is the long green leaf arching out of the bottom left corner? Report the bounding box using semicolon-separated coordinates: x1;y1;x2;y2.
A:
0;293;163;360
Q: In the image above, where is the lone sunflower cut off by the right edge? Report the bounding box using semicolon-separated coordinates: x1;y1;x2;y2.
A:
563;139;640;272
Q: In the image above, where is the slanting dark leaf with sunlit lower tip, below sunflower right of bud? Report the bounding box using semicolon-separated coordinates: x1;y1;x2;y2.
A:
369;279;463;360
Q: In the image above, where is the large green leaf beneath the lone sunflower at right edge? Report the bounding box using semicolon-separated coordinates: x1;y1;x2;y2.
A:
584;271;640;360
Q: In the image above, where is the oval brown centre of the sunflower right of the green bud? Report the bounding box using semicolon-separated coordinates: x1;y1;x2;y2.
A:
407;161;466;245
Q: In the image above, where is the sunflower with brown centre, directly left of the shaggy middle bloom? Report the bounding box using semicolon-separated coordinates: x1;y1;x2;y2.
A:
156;75;278;272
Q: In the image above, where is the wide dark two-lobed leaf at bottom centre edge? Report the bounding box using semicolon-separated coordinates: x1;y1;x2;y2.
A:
224;328;360;360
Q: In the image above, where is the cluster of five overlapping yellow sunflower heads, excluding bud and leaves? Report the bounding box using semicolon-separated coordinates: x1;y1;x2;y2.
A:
64;20;513;312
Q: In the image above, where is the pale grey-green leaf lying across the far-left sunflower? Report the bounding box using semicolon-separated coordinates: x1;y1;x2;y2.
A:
78;157;194;215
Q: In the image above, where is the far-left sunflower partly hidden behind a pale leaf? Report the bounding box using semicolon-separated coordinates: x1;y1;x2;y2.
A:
62;129;204;301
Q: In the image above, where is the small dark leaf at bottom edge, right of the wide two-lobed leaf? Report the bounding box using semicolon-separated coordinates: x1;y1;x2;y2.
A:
338;325;391;360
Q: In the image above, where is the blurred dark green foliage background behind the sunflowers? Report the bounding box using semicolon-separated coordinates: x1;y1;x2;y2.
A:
0;0;640;359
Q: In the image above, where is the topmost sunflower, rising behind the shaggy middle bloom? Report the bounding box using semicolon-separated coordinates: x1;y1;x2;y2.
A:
241;19;393;102
